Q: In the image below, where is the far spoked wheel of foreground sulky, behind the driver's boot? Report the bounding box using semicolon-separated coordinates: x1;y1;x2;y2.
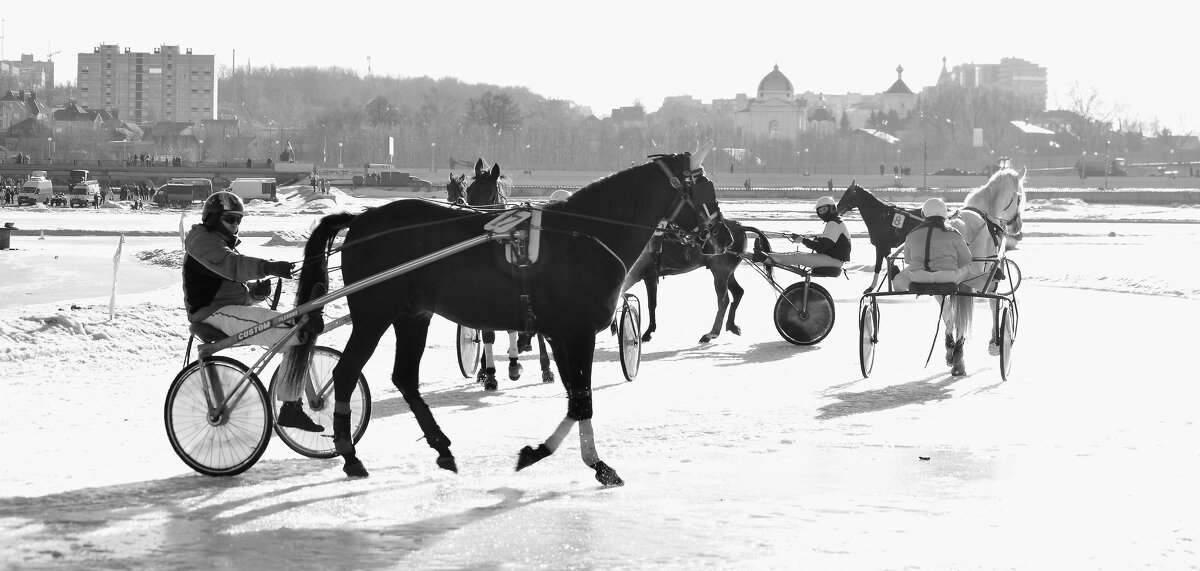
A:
270;347;371;458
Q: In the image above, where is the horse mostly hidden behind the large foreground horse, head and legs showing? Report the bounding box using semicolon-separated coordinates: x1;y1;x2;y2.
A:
458;158;554;391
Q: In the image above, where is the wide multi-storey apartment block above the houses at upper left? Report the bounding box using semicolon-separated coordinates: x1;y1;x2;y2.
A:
76;46;217;125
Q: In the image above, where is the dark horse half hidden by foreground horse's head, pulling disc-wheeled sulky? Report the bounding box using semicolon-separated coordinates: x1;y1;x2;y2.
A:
612;214;770;343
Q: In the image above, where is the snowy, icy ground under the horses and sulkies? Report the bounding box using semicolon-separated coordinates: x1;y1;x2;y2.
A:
0;185;1200;570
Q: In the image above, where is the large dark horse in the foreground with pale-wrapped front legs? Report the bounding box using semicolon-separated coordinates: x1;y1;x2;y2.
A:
283;143;732;486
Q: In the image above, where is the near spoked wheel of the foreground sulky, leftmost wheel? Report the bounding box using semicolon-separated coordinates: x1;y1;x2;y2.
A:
163;356;272;476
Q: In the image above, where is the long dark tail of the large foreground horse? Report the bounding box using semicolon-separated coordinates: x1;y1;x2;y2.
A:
280;212;355;395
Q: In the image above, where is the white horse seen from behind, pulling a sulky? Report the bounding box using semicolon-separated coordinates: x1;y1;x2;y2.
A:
943;168;1026;375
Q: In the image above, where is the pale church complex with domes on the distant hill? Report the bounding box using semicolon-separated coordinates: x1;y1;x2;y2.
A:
733;65;917;142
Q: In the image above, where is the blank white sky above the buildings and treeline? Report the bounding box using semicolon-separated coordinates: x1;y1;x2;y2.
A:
0;0;1200;133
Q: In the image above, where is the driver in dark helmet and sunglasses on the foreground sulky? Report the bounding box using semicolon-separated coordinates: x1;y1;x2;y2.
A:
184;192;325;432
